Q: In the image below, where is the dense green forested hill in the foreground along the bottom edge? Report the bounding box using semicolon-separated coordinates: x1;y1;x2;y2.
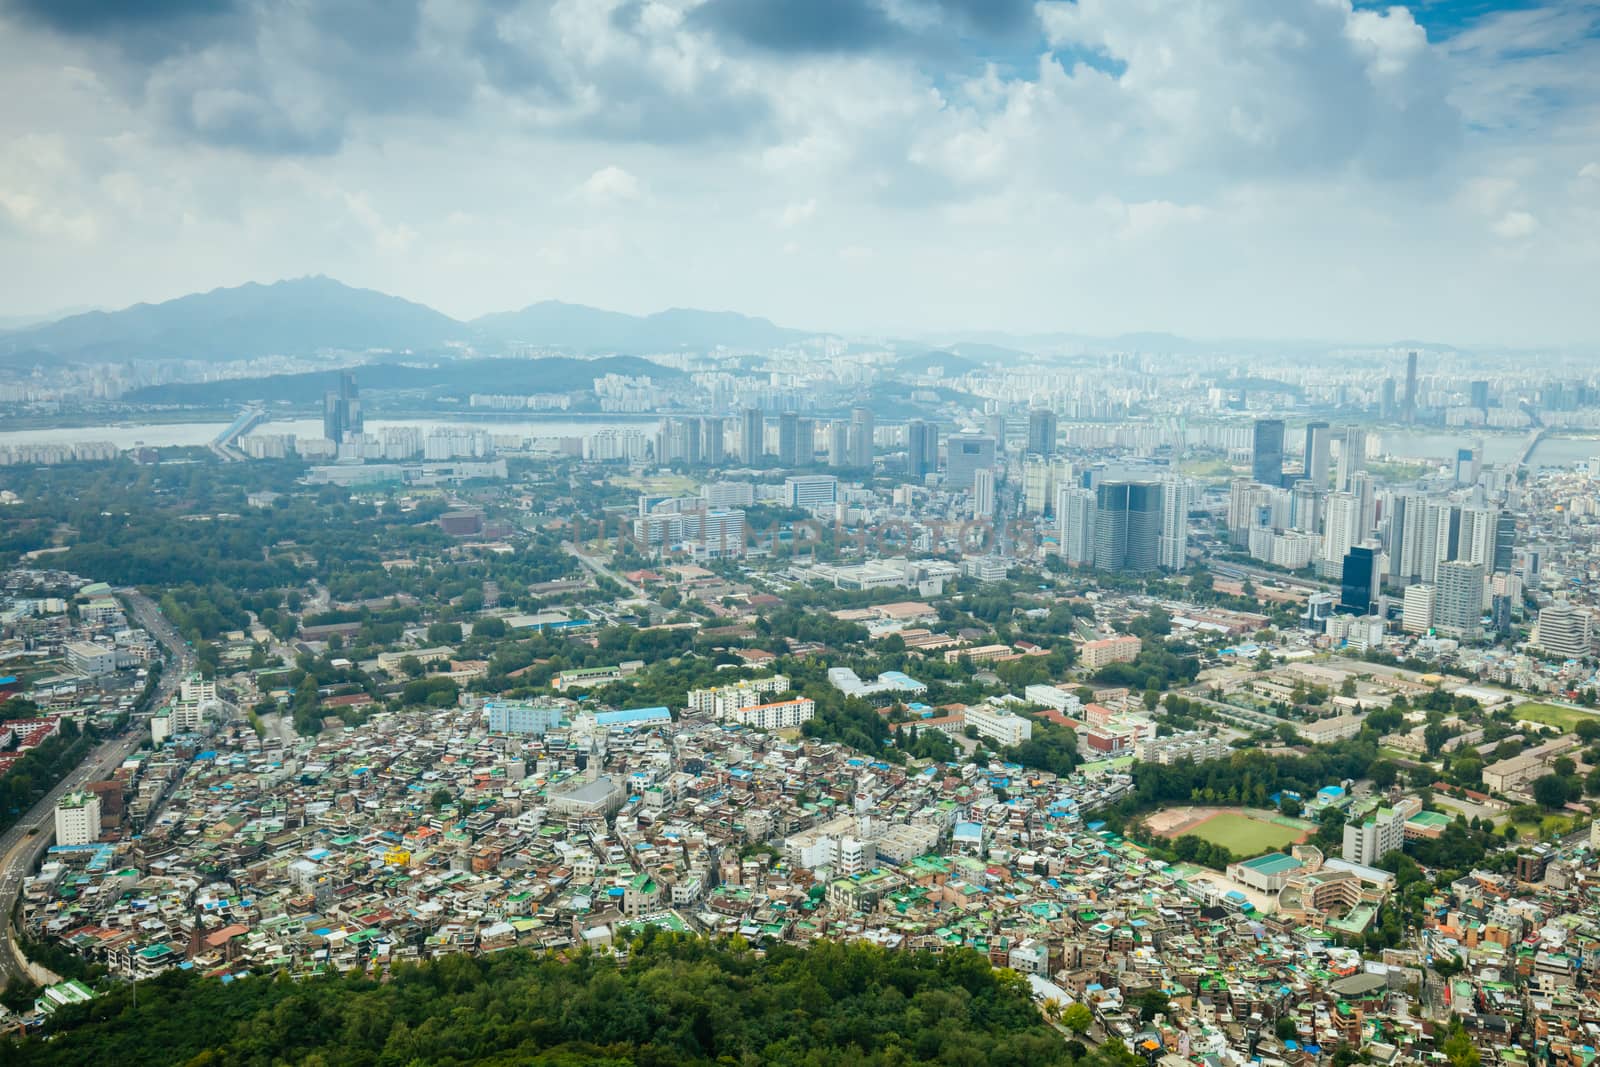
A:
0;931;1142;1067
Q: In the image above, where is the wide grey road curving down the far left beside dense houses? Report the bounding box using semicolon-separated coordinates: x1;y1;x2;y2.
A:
0;589;195;984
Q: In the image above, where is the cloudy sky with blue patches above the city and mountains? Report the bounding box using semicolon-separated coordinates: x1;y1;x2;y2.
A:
0;0;1600;346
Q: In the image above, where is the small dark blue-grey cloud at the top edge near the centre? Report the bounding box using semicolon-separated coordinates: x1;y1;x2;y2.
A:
690;0;910;53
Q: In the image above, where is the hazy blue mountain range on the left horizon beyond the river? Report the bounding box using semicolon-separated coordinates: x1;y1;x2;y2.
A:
0;277;814;366
